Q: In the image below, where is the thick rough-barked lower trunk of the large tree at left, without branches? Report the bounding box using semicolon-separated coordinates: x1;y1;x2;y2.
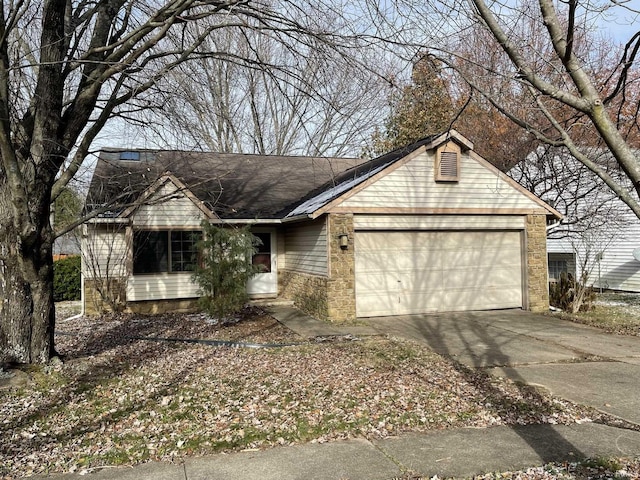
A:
0;183;55;363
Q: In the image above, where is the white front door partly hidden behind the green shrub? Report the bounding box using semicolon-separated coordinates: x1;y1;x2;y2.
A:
247;229;278;298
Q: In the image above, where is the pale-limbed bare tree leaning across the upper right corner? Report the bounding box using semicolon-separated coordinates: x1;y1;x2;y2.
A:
424;0;640;218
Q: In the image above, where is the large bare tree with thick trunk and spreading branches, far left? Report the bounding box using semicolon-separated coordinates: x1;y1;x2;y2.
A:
0;0;370;363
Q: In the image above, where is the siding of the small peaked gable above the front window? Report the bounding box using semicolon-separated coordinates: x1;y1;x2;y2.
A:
133;182;205;230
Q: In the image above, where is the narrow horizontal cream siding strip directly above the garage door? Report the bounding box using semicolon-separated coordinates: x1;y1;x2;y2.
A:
353;215;526;230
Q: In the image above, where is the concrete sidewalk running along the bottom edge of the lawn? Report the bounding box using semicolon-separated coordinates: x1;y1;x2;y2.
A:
31;424;640;480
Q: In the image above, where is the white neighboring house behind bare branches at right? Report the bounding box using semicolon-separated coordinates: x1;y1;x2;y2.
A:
509;147;640;292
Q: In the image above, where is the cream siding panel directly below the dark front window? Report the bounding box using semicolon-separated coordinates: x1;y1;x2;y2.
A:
127;272;198;302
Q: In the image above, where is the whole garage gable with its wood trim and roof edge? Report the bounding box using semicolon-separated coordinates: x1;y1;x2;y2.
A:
287;130;560;218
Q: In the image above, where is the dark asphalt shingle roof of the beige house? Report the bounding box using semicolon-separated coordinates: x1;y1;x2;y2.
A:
86;136;435;219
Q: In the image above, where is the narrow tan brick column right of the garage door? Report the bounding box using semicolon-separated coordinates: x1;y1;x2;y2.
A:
526;215;549;312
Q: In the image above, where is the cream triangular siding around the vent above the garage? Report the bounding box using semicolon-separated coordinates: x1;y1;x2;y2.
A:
339;152;542;210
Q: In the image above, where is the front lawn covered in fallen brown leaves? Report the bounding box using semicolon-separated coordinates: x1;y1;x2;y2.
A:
0;312;590;478
